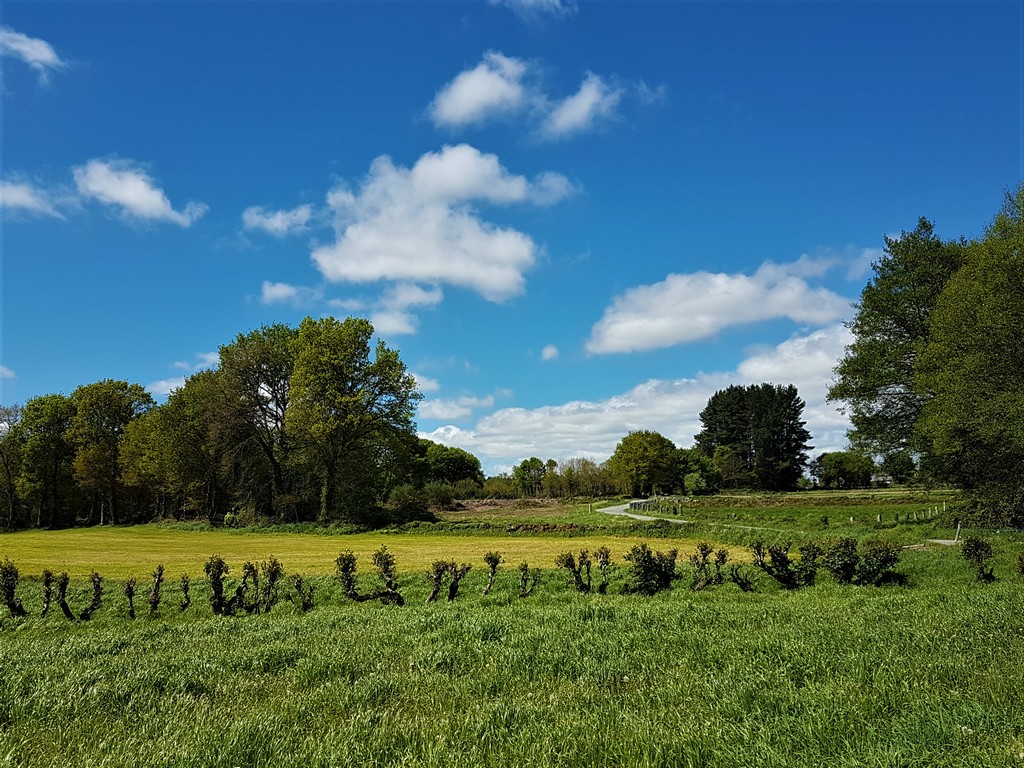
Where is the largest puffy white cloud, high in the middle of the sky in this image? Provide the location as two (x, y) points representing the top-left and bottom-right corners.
(312, 144), (572, 309)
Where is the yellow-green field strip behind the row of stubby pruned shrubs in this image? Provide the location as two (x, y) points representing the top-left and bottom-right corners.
(0, 525), (720, 579)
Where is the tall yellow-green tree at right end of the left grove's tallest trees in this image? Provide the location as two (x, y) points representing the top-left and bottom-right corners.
(288, 317), (421, 521)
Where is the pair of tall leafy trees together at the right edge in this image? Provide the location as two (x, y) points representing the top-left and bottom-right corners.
(828, 184), (1024, 527)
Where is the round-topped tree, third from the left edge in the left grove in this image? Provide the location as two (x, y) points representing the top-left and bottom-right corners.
(70, 379), (155, 524)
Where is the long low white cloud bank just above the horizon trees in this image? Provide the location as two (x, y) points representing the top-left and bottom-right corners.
(421, 325), (850, 473)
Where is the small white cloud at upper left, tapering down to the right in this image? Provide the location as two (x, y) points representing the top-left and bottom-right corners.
(74, 160), (208, 226)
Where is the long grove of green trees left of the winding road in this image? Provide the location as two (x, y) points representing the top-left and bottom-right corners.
(0, 317), (483, 529)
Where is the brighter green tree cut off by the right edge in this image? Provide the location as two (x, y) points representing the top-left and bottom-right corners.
(918, 184), (1024, 525)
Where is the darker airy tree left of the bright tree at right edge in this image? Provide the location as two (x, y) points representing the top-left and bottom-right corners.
(828, 218), (967, 456)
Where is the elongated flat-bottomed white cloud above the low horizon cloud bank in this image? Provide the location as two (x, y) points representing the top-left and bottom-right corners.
(587, 257), (850, 354)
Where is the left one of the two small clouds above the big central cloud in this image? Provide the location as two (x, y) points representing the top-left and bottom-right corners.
(430, 51), (526, 127)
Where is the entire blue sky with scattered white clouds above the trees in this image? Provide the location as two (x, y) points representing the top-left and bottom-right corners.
(0, 0), (1024, 472)
